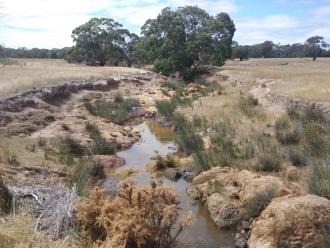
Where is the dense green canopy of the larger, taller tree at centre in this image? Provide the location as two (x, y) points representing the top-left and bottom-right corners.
(135, 6), (235, 76)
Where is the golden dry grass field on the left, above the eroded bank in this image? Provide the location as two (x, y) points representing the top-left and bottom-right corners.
(0, 59), (147, 98)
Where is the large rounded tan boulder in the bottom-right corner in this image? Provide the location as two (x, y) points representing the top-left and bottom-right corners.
(248, 194), (330, 248)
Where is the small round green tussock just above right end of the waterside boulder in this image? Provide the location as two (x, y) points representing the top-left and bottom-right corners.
(256, 151), (282, 172)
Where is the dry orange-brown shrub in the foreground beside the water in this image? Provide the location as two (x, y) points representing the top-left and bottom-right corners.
(77, 180), (192, 248)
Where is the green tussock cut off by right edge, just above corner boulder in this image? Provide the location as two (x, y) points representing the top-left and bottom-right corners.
(307, 160), (330, 199)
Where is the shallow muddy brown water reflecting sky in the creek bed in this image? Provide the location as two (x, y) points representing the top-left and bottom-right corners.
(107, 121), (234, 248)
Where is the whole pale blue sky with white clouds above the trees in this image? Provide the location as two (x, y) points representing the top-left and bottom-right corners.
(0, 0), (330, 48)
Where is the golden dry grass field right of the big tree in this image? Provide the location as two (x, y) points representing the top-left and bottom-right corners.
(220, 58), (330, 101)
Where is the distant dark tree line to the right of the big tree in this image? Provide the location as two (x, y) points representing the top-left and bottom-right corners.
(233, 36), (330, 60)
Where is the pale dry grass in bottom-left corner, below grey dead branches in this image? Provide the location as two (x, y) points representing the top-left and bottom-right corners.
(0, 215), (81, 248)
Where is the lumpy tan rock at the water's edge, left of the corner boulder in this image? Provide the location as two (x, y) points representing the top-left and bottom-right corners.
(188, 167), (292, 232)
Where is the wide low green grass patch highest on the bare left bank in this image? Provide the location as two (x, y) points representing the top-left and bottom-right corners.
(85, 95), (139, 125)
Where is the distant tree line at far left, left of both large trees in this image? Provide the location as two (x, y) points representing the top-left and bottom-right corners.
(0, 46), (70, 59)
